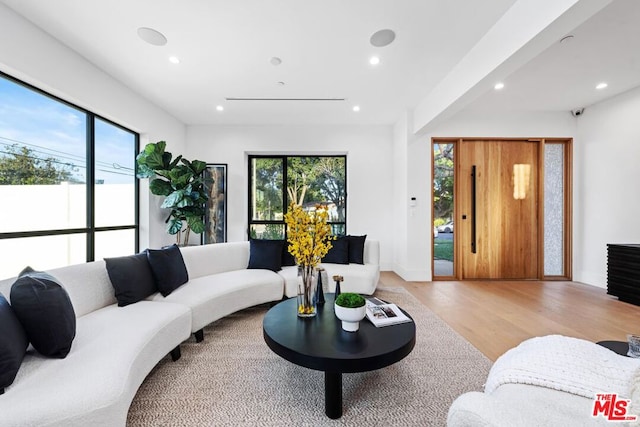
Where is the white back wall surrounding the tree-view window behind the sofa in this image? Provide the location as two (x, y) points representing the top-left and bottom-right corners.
(186, 125), (396, 270)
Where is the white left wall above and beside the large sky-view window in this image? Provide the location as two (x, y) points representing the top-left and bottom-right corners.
(0, 4), (185, 248)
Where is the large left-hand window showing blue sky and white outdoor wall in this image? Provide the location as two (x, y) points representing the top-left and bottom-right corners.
(0, 73), (139, 279)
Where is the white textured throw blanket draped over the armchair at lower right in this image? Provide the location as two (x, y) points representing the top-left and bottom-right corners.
(485, 335), (640, 400)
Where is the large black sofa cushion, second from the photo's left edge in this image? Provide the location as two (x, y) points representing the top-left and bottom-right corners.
(11, 267), (76, 359)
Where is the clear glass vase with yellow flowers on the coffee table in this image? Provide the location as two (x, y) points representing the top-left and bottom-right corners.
(284, 203), (335, 317)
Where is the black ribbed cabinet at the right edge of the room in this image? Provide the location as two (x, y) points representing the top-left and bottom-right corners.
(607, 244), (640, 305)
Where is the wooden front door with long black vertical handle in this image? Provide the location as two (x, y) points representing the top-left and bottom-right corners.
(455, 140), (539, 279)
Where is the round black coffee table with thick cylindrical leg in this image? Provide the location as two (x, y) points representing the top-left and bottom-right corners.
(262, 294), (416, 419)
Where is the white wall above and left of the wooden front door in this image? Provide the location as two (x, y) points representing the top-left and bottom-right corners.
(404, 110), (576, 280)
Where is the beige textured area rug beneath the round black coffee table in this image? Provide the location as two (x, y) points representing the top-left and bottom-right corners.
(127, 288), (491, 426)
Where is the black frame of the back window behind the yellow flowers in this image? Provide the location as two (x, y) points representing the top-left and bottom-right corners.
(247, 154), (348, 240)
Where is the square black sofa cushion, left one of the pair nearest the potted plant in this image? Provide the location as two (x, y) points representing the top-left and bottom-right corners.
(104, 252), (158, 307)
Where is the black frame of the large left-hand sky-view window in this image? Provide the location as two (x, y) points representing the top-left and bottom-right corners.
(0, 71), (140, 262)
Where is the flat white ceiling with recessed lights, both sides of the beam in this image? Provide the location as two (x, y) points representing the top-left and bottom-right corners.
(0, 0), (640, 124)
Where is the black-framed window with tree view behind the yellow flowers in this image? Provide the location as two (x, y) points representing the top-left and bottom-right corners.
(249, 156), (347, 239)
